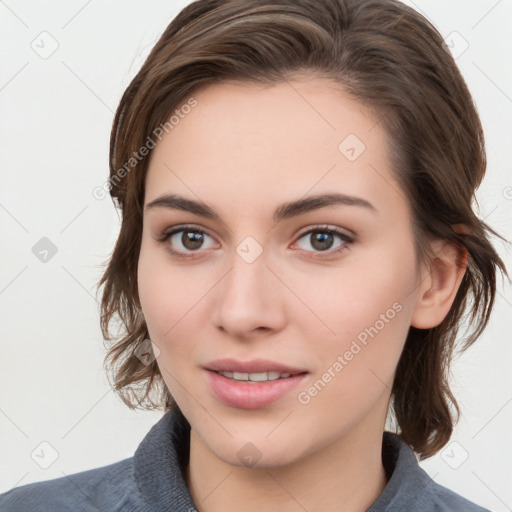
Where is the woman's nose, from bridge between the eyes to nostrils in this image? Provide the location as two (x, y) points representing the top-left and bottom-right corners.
(213, 242), (286, 339)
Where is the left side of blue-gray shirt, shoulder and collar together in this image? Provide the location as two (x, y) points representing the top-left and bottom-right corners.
(0, 412), (195, 512)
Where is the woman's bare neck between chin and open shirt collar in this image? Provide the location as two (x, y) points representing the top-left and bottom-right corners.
(185, 414), (387, 512)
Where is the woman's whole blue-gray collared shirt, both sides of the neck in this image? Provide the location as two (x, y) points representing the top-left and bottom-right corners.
(0, 410), (490, 512)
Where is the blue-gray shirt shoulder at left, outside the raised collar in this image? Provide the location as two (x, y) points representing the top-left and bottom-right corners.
(0, 457), (139, 512)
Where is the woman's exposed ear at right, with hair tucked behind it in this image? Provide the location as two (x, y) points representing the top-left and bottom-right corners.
(411, 234), (469, 329)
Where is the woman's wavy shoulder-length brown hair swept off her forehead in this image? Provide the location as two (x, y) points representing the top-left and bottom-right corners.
(98, 0), (508, 459)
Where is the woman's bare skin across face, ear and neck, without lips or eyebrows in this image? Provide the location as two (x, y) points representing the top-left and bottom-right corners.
(138, 77), (464, 512)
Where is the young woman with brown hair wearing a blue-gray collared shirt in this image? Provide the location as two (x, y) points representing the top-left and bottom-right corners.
(0, 0), (506, 512)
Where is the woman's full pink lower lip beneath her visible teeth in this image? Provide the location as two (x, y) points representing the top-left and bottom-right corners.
(206, 370), (307, 409)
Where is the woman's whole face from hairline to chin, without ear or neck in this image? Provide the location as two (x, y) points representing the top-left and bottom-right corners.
(138, 79), (424, 467)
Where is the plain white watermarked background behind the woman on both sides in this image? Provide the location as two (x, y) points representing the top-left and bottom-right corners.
(0, 0), (512, 511)
